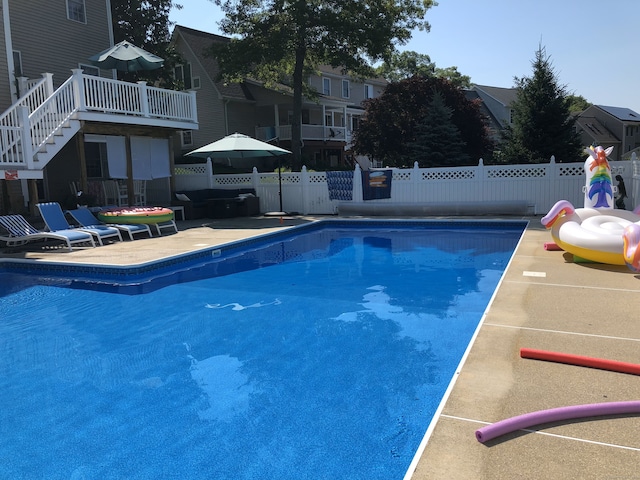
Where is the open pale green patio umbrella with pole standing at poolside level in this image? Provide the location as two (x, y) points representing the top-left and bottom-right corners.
(186, 133), (291, 213)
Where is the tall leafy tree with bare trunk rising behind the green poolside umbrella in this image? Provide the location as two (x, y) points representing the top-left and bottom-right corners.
(212, 0), (436, 169)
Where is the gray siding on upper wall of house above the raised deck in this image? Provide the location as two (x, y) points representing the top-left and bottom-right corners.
(9, 0), (111, 87)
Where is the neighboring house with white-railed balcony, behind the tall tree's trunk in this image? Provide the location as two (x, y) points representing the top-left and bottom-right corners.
(173, 25), (387, 168)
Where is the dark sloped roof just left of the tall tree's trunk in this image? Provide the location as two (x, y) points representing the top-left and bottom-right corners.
(173, 25), (253, 100)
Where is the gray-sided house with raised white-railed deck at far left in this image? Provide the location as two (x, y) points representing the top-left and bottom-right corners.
(0, 0), (198, 212)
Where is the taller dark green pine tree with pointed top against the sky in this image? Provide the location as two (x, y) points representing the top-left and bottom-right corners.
(502, 46), (582, 163)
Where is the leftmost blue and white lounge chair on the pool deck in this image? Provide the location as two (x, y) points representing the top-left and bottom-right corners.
(0, 215), (96, 251)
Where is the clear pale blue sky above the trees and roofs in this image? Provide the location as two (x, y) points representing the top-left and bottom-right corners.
(170, 0), (640, 113)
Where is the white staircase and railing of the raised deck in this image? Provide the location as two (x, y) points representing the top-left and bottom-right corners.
(0, 69), (198, 180)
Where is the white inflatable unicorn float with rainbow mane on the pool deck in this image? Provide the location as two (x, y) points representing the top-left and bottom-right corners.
(542, 146), (640, 272)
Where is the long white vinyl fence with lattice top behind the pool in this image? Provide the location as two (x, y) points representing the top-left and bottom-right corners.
(174, 155), (640, 215)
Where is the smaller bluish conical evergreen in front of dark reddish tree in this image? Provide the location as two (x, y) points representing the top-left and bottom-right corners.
(407, 90), (470, 168)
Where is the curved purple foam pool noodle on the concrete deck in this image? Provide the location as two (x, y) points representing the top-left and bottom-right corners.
(476, 401), (640, 443)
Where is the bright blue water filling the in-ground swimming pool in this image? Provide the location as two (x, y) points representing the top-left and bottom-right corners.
(0, 222), (524, 480)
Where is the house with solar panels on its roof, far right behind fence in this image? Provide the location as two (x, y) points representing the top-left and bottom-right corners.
(576, 105), (640, 160)
